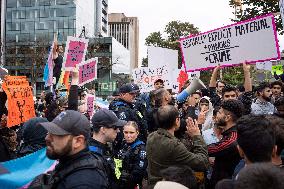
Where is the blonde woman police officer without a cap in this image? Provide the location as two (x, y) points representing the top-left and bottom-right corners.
(118, 121), (147, 189)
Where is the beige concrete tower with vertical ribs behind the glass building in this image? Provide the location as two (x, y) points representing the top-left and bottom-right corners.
(108, 13), (139, 70)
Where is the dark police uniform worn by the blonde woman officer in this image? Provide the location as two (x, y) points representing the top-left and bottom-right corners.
(118, 139), (148, 189)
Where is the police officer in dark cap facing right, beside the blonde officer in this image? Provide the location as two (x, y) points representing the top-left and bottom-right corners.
(89, 109), (126, 189)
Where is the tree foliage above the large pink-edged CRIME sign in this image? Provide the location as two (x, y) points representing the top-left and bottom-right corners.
(229, 0), (284, 34)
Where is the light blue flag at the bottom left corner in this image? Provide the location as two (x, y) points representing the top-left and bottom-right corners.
(0, 148), (57, 189)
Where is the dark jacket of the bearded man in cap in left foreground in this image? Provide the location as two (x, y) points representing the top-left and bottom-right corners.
(29, 149), (108, 189)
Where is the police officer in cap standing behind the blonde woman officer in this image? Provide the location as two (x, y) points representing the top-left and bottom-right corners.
(110, 84), (147, 142)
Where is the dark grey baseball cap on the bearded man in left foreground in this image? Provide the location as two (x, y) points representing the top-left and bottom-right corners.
(40, 110), (91, 139)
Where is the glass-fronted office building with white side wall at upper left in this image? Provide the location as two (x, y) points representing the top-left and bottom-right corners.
(1, 0), (108, 91)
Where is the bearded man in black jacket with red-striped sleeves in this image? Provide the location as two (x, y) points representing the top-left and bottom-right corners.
(208, 100), (244, 188)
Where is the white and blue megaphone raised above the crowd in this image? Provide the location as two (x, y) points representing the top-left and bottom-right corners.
(177, 77), (206, 103)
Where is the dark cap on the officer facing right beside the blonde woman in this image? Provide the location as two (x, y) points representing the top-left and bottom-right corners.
(92, 108), (127, 127)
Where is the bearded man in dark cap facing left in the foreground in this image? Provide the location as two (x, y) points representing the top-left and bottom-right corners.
(29, 110), (108, 189)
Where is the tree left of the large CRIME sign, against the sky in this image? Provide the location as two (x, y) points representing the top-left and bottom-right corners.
(143, 21), (199, 68)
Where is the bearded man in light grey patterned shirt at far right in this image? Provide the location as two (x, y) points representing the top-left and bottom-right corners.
(251, 83), (276, 115)
